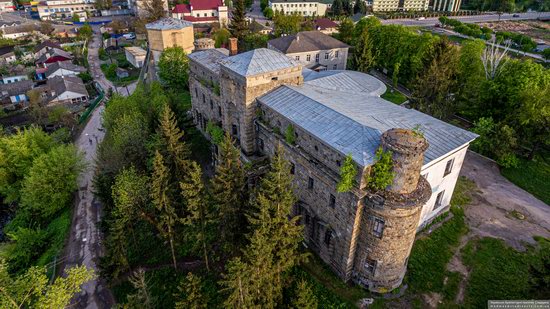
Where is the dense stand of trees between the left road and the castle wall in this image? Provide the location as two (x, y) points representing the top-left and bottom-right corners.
(94, 84), (315, 308)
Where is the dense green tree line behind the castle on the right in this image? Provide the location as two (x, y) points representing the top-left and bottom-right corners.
(338, 18), (550, 167)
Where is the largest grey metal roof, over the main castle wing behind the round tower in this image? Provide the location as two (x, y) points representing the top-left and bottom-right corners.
(258, 71), (477, 166)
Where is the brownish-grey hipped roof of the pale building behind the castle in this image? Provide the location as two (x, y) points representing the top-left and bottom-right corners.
(268, 31), (349, 54)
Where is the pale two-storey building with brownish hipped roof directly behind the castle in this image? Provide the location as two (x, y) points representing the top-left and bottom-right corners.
(267, 31), (349, 71)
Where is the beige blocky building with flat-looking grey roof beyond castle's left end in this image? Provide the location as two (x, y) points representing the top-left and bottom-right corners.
(145, 18), (195, 63)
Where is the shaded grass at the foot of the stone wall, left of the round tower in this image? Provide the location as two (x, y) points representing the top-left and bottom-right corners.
(300, 250), (370, 308)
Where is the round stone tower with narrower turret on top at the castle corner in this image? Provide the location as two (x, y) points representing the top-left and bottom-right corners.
(361, 129), (431, 293)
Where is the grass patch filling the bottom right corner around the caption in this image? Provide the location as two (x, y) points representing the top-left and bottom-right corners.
(462, 238), (550, 308)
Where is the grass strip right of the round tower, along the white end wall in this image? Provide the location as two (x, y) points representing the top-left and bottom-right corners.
(405, 177), (475, 298)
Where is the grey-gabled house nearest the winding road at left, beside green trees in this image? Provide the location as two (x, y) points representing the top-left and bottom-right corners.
(46, 75), (88, 105)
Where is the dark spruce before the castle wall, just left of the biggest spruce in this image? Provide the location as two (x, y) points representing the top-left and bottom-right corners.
(211, 133), (248, 253)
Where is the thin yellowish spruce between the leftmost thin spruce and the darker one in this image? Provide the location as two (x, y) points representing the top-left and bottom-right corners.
(180, 162), (214, 270)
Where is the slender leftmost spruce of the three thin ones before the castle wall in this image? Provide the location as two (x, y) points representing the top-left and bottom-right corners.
(151, 151), (179, 269)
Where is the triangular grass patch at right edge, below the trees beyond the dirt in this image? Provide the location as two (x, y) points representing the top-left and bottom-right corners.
(501, 156), (550, 205)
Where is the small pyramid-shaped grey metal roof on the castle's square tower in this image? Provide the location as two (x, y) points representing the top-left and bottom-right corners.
(220, 48), (300, 76)
